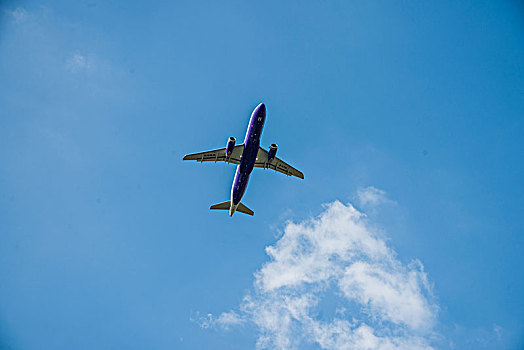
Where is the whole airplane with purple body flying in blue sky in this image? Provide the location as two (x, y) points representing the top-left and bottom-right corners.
(183, 103), (304, 216)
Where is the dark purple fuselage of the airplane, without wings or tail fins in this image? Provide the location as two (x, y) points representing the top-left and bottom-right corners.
(229, 103), (266, 215)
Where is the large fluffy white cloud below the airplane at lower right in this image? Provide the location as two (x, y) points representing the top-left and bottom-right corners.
(201, 201), (438, 349)
